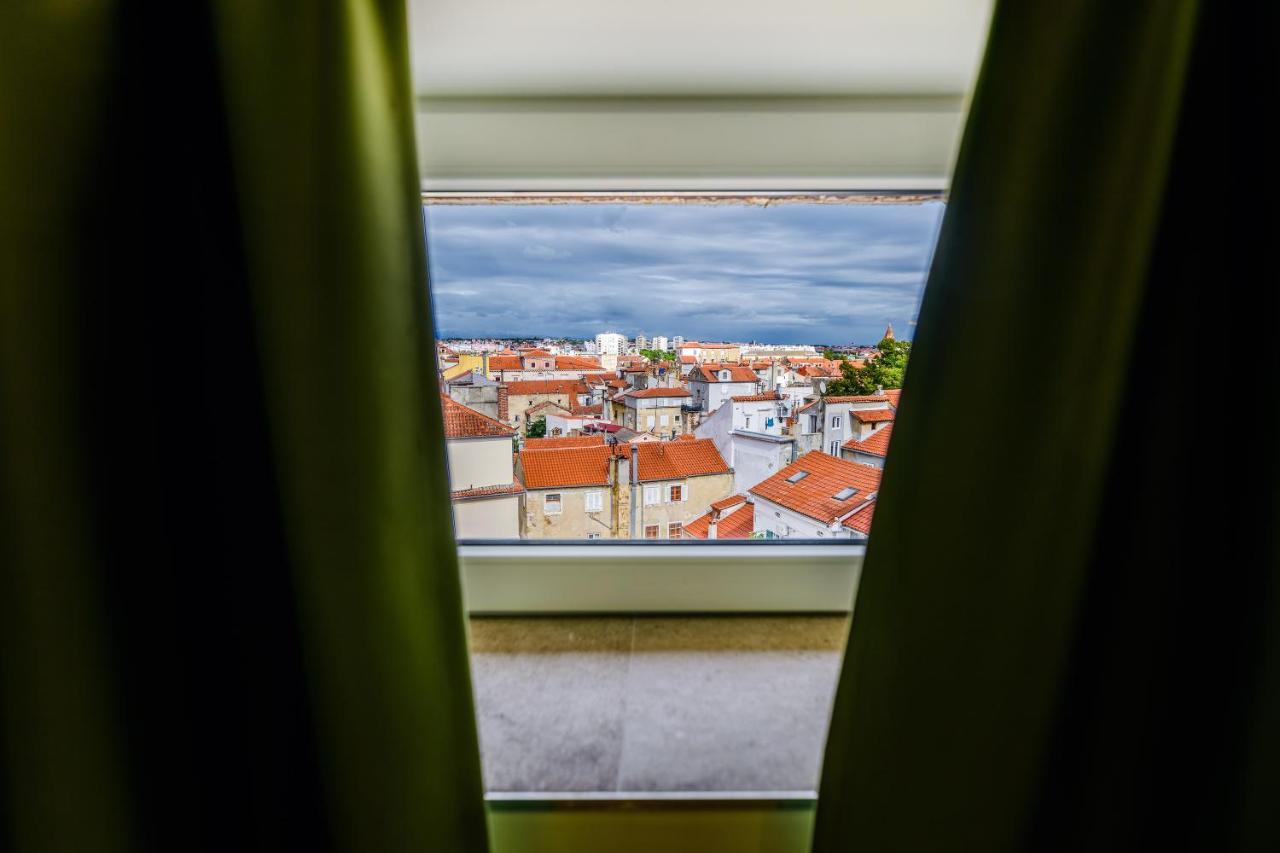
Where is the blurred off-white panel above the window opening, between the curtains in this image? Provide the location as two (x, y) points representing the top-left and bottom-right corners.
(408, 0), (992, 190)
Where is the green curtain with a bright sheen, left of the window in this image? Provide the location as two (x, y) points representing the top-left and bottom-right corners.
(0, 0), (486, 852)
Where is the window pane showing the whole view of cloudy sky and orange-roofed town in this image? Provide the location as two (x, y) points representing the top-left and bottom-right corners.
(426, 197), (942, 540)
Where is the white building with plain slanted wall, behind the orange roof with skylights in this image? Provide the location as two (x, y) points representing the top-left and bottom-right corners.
(695, 394), (796, 493)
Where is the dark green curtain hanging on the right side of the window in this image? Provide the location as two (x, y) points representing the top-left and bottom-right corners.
(814, 0), (1280, 853)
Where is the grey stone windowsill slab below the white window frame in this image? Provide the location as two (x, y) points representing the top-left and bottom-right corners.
(471, 616), (849, 803)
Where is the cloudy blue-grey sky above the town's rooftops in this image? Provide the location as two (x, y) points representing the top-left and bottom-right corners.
(426, 202), (942, 345)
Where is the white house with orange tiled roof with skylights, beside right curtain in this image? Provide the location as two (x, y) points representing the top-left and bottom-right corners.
(750, 451), (881, 540)
